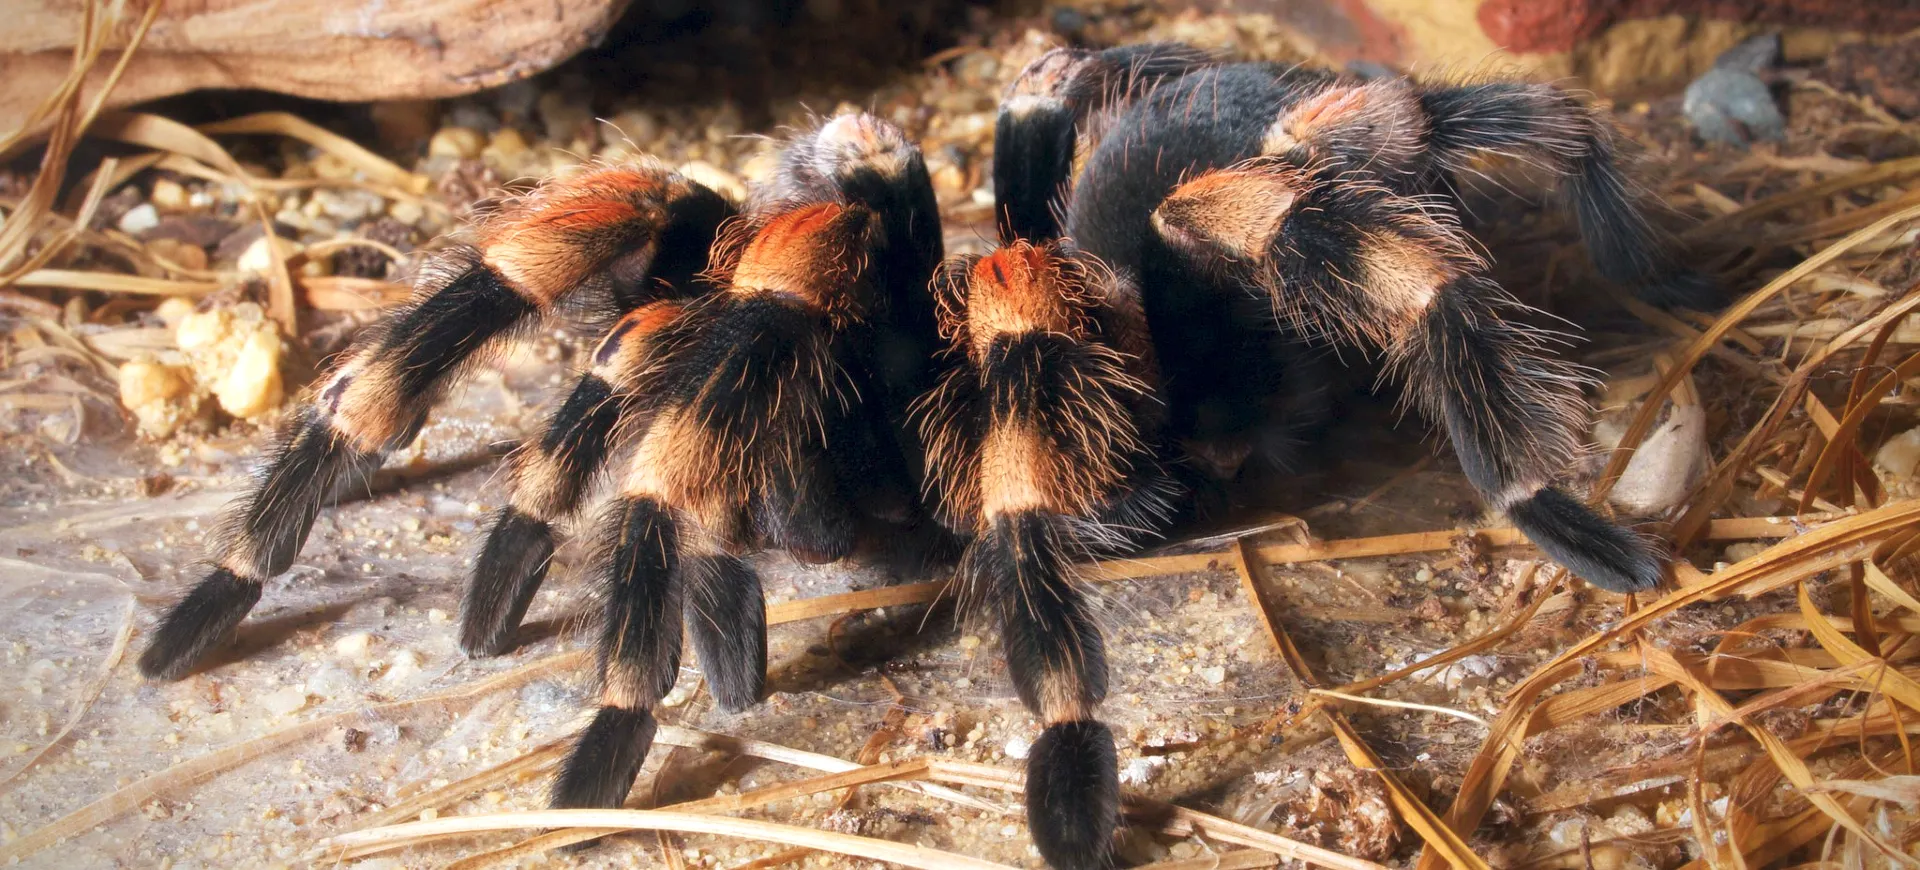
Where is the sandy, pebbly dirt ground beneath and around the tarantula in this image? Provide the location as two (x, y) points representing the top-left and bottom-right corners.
(0, 3), (1920, 868)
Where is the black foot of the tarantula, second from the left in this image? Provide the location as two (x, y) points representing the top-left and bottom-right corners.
(461, 507), (553, 659)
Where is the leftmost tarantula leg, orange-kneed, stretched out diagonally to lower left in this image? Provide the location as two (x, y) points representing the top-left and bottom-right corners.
(140, 169), (726, 680)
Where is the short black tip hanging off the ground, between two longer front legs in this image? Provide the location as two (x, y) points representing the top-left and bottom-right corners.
(682, 553), (766, 713)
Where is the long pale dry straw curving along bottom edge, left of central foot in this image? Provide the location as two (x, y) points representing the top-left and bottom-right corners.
(326, 810), (1006, 870)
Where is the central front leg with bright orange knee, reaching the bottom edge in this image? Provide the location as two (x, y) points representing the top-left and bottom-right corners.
(920, 242), (1171, 870)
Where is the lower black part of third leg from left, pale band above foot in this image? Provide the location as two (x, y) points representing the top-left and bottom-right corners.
(549, 497), (682, 809)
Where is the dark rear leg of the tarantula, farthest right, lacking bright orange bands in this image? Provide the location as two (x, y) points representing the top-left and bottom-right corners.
(1419, 83), (1722, 309)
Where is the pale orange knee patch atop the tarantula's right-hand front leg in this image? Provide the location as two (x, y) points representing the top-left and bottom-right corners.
(1152, 169), (1302, 263)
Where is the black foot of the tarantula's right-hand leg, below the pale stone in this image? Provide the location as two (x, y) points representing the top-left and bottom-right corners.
(1507, 488), (1665, 592)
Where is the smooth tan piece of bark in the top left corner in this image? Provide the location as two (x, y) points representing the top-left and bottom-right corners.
(0, 0), (630, 136)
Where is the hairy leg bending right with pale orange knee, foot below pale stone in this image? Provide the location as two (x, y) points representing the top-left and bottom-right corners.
(1154, 159), (1663, 592)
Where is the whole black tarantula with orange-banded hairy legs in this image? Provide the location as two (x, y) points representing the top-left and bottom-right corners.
(140, 44), (1713, 868)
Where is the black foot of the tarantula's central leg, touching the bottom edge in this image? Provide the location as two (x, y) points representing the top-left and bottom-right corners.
(1027, 720), (1119, 870)
